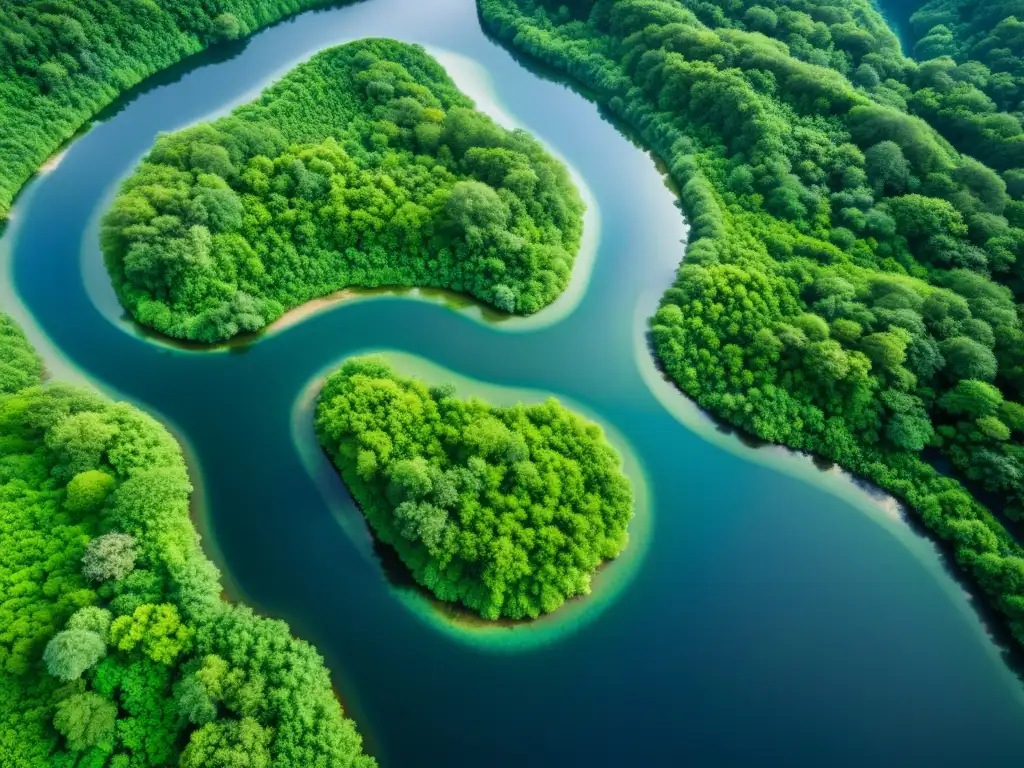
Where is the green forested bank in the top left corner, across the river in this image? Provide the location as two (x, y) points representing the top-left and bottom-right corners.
(0, 0), (364, 218)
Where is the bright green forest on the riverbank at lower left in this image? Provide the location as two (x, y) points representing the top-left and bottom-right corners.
(0, 317), (375, 768)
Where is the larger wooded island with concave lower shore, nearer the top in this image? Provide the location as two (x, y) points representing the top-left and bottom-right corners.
(102, 40), (583, 342)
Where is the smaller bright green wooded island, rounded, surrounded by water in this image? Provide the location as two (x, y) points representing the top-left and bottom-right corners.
(315, 357), (633, 620)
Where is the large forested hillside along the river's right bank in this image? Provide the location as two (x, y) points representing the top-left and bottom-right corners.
(479, 0), (1024, 651)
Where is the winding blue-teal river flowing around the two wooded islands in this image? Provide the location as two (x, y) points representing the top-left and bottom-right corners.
(3, 0), (1024, 766)
